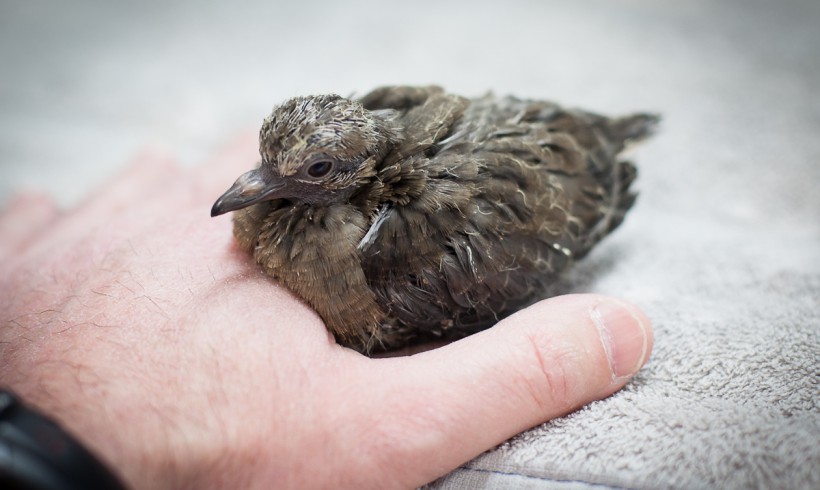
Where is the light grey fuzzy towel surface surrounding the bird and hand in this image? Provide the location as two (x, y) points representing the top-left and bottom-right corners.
(0, 0), (820, 488)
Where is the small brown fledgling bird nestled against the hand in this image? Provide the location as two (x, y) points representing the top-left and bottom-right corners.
(211, 86), (660, 355)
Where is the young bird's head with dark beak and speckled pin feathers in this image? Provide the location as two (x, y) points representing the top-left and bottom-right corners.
(211, 95), (396, 216)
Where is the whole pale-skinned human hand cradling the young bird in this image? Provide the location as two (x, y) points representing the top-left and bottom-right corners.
(0, 131), (652, 489)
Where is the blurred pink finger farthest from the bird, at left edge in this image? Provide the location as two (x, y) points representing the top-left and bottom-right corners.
(0, 192), (58, 257)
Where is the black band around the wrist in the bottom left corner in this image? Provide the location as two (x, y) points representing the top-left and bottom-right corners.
(0, 389), (124, 490)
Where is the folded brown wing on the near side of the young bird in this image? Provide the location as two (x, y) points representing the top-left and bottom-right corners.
(363, 95), (652, 332)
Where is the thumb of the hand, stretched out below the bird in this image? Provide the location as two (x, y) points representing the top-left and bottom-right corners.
(362, 295), (652, 486)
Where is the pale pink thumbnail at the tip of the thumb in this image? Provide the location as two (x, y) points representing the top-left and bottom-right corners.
(590, 300), (649, 378)
